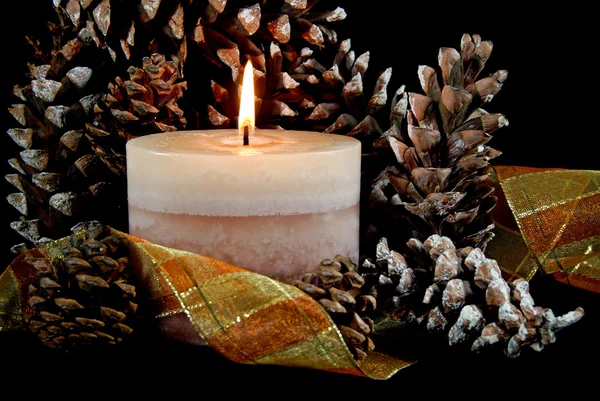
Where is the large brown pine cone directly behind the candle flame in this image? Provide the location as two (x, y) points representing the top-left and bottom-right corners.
(193, 1), (368, 131)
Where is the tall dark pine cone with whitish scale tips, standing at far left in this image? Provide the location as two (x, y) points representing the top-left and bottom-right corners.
(6, 49), (118, 248)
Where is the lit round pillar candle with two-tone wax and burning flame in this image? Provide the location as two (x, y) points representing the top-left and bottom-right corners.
(126, 61), (361, 282)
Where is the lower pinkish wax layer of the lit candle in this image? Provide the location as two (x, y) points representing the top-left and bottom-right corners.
(129, 204), (359, 283)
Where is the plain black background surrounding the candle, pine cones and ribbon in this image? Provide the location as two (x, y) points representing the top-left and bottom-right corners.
(0, 0), (600, 399)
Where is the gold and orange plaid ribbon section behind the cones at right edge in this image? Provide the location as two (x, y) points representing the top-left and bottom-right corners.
(486, 166), (600, 292)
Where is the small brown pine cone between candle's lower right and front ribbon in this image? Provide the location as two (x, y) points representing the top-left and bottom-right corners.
(293, 255), (377, 360)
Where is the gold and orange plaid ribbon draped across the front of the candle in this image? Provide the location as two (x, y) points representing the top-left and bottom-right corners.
(0, 230), (413, 380)
